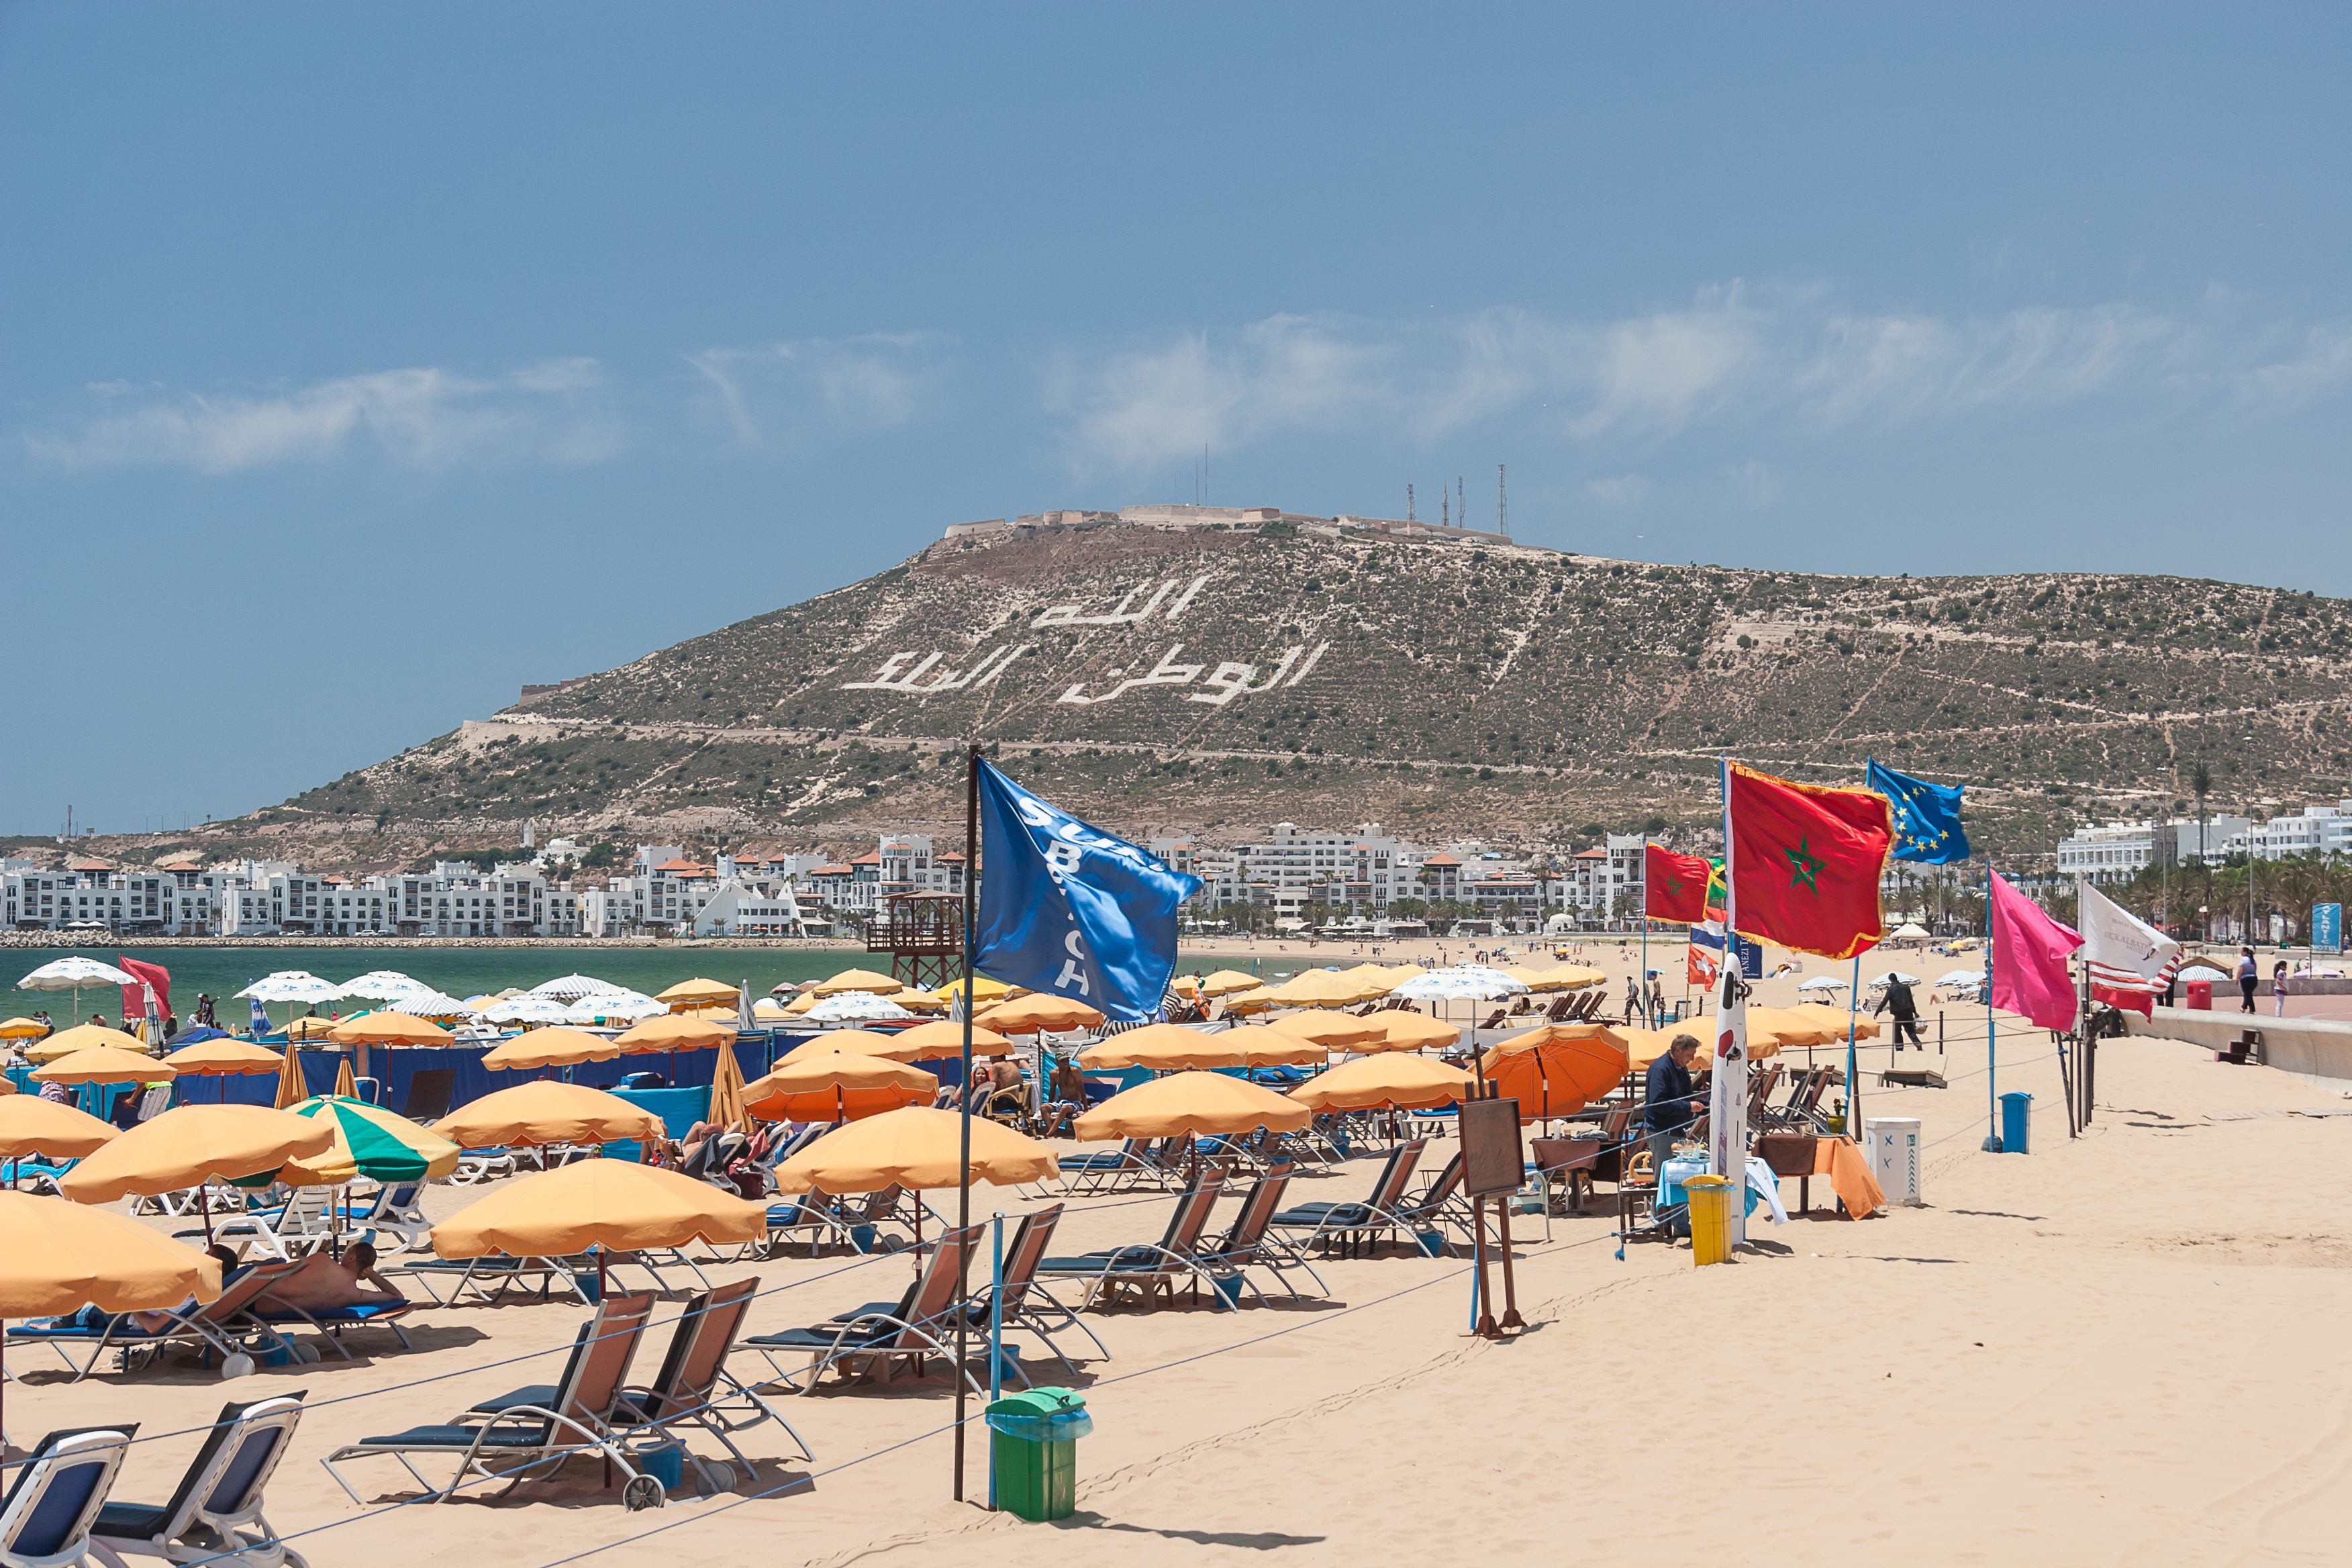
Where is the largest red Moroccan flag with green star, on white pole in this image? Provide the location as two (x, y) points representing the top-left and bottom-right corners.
(1724, 762), (1894, 959)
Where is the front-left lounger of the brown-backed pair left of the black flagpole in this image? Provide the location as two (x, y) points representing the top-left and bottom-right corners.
(320, 1295), (661, 1509)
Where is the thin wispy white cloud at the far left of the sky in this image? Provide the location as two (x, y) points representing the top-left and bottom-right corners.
(28, 360), (621, 475)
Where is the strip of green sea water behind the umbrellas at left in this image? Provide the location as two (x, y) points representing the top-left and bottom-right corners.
(0, 947), (865, 1027)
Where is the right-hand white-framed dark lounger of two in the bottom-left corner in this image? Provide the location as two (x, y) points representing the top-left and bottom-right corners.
(89, 1391), (308, 1568)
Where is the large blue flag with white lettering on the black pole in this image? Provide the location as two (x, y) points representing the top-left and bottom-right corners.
(971, 762), (1202, 1022)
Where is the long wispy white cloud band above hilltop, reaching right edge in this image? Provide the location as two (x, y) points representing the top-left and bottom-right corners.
(1046, 285), (2352, 472)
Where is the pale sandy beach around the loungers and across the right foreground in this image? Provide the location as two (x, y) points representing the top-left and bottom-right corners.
(7, 975), (2352, 1568)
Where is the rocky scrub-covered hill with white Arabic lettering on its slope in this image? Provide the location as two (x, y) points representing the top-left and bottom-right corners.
(114, 524), (2352, 863)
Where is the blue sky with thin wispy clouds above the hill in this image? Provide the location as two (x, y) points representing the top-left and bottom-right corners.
(0, 5), (2352, 832)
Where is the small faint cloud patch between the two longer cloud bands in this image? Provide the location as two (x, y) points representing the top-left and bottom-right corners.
(687, 334), (948, 449)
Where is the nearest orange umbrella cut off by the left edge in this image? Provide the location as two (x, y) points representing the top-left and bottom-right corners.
(0, 1192), (221, 1319)
